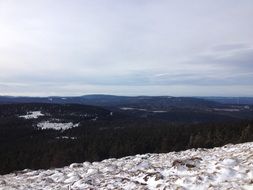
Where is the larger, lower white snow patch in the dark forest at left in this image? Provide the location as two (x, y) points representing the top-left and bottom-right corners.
(37, 121), (79, 131)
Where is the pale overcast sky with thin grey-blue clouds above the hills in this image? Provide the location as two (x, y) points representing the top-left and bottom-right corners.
(0, 0), (253, 96)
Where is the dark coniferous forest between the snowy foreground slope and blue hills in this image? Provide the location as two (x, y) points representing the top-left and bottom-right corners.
(0, 103), (253, 174)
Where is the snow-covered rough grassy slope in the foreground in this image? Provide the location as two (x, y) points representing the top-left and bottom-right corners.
(0, 143), (253, 190)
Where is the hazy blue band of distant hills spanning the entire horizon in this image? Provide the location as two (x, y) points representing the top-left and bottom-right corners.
(0, 94), (253, 109)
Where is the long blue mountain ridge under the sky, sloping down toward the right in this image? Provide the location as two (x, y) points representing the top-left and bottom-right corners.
(0, 94), (223, 106)
